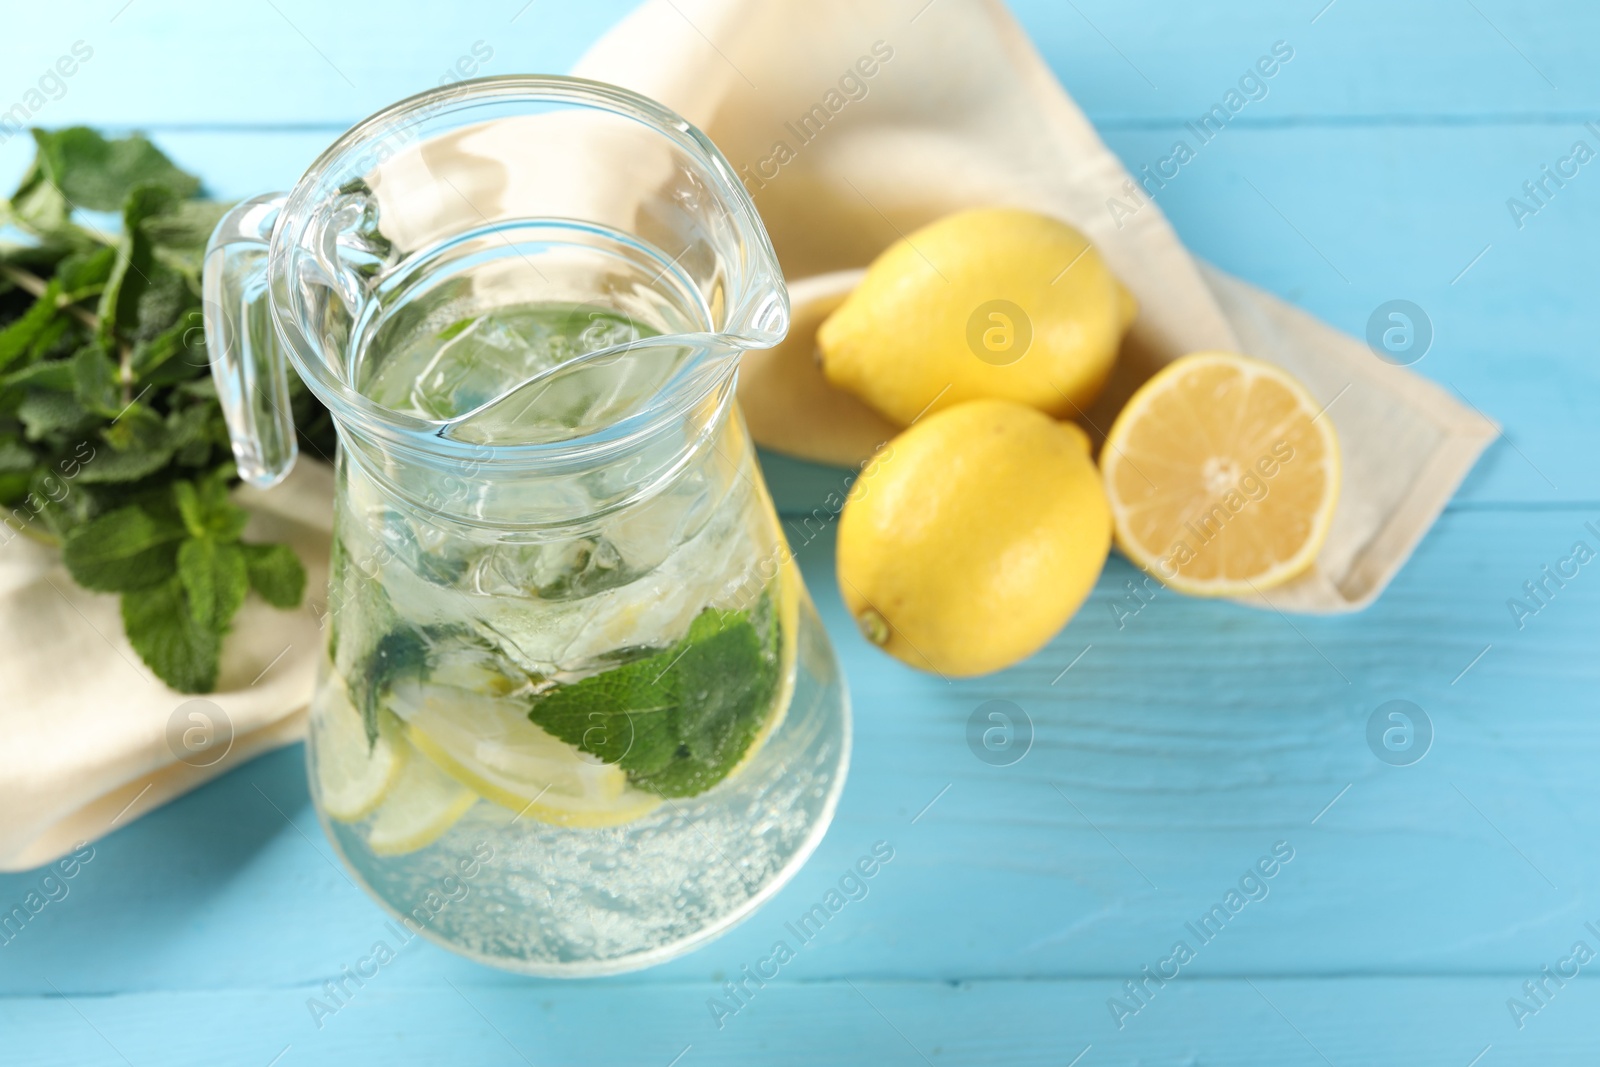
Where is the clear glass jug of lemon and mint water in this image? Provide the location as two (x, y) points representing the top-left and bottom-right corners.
(205, 77), (850, 976)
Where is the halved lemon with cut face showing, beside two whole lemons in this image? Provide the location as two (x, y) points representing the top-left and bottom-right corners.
(1101, 352), (1339, 597)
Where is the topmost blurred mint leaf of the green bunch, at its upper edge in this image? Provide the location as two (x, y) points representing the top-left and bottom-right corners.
(19, 126), (200, 211)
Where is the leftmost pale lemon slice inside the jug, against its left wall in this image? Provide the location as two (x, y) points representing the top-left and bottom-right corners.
(310, 677), (406, 822)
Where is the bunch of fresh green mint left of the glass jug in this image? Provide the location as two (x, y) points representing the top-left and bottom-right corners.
(0, 126), (333, 693)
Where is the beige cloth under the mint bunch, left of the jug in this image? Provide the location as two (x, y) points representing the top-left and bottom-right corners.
(0, 459), (333, 870)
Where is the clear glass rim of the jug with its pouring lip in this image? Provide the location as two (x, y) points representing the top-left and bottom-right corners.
(267, 74), (789, 467)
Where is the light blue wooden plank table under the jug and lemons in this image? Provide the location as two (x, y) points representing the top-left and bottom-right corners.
(0, 0), (1600, 1067)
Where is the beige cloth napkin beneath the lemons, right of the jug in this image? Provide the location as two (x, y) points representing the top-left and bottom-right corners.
(574, 0), (1498, 613)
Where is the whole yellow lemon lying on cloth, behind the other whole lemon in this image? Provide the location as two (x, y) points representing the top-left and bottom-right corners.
(816, 208), (1138, 426)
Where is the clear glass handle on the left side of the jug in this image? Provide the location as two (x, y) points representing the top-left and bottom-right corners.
(202, 194), (299, 490)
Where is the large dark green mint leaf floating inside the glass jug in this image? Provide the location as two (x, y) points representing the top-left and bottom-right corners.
(528, 593), (778, 797)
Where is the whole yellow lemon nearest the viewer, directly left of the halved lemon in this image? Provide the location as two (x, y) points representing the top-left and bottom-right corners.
(838, 400), (1110, 675)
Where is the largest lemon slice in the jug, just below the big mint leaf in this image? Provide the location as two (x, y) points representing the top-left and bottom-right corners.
(390, 683), (661, 827)
